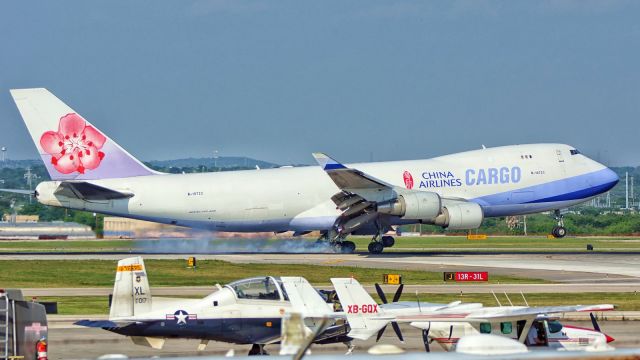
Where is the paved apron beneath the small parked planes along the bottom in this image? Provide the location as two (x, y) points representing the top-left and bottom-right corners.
(49, 321), (640, 359)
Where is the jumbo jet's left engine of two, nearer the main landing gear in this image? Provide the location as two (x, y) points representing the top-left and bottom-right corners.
(378, 191), (442, 221)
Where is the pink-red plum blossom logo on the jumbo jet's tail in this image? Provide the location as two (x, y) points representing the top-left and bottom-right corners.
(40, 113), (107, 174)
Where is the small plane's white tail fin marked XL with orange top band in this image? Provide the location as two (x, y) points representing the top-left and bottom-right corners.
(109, 256), (151, 320)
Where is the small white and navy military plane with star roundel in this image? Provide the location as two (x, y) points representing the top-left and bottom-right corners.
(75, 256), (351, 355)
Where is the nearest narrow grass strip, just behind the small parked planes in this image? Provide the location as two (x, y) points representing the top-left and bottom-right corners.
(38, 293), (640, 315)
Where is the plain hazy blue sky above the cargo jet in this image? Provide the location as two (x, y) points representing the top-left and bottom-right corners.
(0, 0), (640, 166)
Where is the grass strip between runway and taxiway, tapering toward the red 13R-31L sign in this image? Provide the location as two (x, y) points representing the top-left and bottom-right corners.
(0, 260), (548, 288)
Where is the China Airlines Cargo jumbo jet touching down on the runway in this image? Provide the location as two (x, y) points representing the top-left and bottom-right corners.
(2, 89), (619, 253)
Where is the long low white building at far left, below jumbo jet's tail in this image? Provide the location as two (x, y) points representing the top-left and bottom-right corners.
(0, 221), (96, 240)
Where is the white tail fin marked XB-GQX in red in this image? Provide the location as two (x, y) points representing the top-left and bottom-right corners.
(331, 278), (392, 340)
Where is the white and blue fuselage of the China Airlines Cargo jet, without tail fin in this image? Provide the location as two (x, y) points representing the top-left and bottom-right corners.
(37, 144), (618, 232)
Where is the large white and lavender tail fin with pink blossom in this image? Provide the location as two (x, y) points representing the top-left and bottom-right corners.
(11, 88), (157, 180)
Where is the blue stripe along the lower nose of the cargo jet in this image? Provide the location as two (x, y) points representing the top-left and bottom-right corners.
(471, 168), (620, 207)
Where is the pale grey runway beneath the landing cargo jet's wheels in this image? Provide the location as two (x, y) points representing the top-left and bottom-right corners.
(7, 252), (640, 285)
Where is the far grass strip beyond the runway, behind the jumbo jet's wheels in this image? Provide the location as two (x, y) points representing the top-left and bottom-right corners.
(0, 236), (640, 253)
